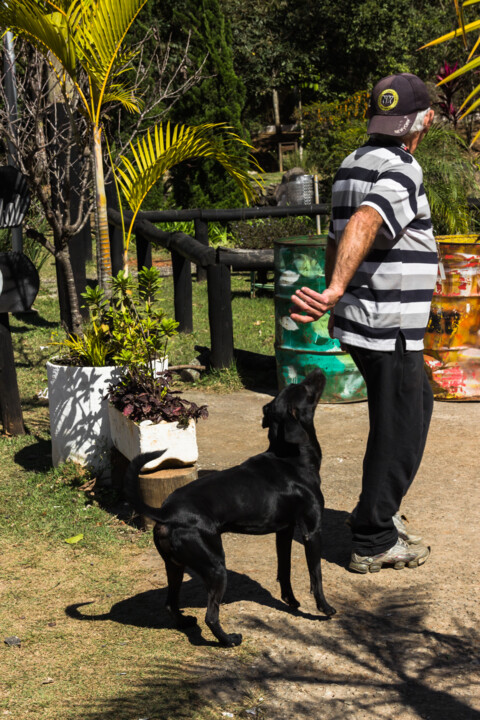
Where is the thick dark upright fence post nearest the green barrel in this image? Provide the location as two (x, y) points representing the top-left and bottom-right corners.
(207, 263), (233, 369)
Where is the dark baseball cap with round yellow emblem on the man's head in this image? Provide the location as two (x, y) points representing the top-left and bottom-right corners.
(367, 73), (430, 137)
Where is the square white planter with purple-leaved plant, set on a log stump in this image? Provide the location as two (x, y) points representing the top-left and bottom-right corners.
(108, 404), (198, 470)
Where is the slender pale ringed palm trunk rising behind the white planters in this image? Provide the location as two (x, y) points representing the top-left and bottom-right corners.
(93, 125), (112, 295)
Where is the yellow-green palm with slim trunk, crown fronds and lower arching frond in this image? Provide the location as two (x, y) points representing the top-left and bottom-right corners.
(0, 0), (260, 287)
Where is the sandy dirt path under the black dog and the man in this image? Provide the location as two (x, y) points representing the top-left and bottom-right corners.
(138, 391), (480, 720)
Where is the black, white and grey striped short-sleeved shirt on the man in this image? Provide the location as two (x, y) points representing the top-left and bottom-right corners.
(329, 139), (437, 351)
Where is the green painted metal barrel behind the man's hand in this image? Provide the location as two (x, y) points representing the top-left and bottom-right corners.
(275, 235), (367, 403)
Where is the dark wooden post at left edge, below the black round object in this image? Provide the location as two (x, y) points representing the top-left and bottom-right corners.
(0, 313), (25, 435)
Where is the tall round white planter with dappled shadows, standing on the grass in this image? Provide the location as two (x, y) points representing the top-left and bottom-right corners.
(47, 360), (168, 474)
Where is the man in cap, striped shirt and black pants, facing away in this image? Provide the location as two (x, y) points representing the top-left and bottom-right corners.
(292, 73), (437, 573)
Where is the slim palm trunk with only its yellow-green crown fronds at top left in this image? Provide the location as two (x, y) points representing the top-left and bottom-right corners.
(0, 0), (146, 285)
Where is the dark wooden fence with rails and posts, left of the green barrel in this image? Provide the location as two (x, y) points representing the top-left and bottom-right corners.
(108, 204), (330, 368)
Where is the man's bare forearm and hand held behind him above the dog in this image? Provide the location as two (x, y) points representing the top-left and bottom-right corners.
(291, 205), (383, 323)
